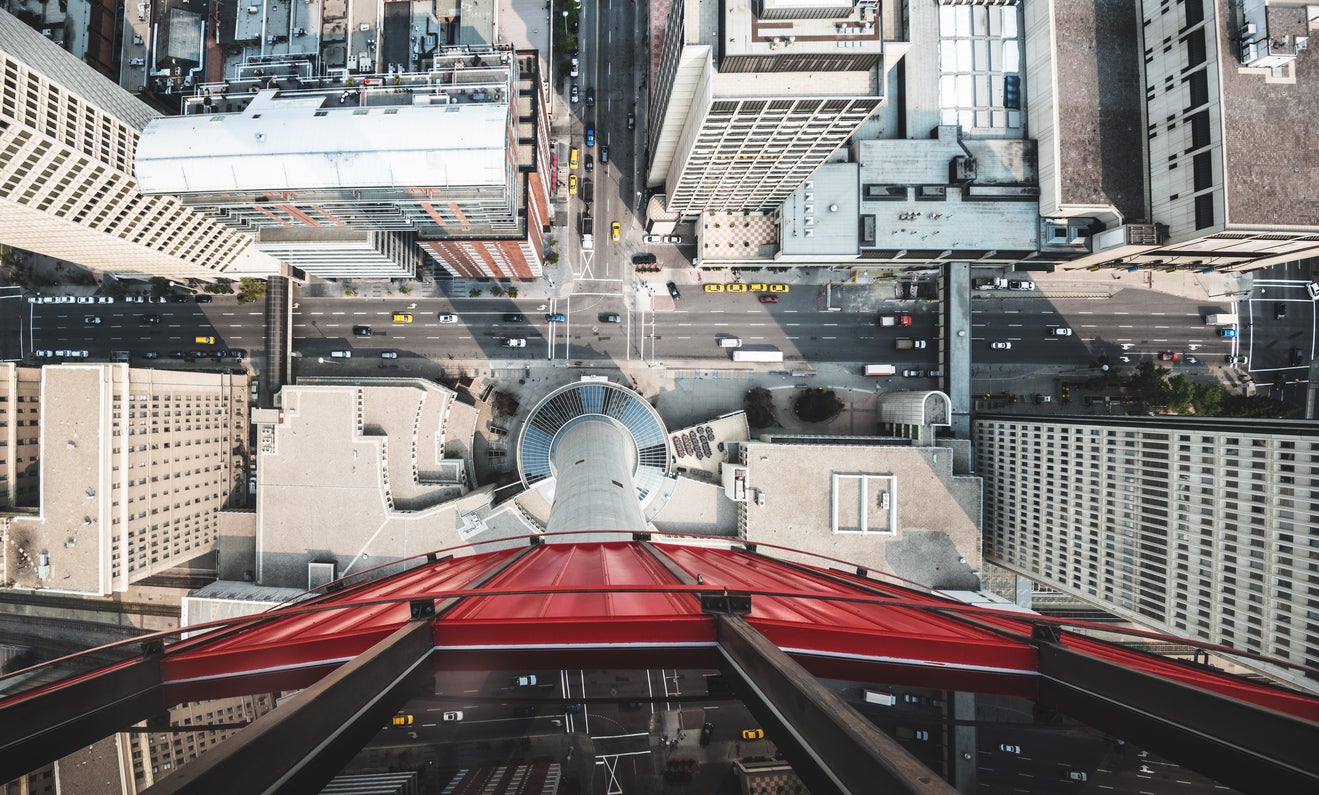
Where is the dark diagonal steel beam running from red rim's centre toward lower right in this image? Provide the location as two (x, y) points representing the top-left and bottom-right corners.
(714, 614), (956, 795)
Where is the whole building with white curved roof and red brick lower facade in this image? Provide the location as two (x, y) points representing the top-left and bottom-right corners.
(136, 47), (550, 278)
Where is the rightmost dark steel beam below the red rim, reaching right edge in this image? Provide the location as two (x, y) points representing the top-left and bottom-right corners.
(1035, 638), (1319, 792)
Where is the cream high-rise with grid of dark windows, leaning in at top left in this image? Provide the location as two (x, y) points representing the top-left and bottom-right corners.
(0, 11), (278, 278)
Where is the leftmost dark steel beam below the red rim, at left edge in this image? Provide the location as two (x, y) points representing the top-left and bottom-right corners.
(0, 646), (165, 782)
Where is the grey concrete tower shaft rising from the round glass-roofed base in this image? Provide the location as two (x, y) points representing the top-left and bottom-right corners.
(546, 417), (646, 542)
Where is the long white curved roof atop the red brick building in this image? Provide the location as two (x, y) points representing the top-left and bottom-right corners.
(135, 91), (508, 195)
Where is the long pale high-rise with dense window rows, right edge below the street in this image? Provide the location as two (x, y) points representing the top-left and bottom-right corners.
(973, 415), (1319, 688)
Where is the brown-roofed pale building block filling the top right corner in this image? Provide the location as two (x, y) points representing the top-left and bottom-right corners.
(1022, 0), (1319, 268)
